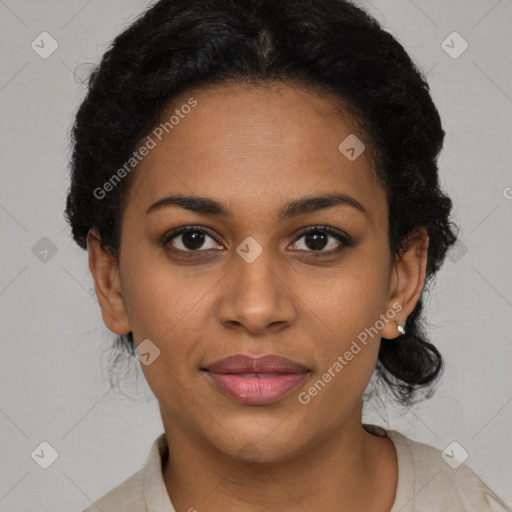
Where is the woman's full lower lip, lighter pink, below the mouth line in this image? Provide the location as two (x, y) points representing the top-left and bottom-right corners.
(206, 372), (308, 404)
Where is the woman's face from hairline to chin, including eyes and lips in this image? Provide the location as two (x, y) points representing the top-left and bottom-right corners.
(91, 85), (420, 461)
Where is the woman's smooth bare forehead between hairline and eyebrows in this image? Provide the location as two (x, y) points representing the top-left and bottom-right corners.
(127, 84), (386, 222)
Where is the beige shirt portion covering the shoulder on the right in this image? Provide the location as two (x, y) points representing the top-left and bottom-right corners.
(364, 426), (512, 512)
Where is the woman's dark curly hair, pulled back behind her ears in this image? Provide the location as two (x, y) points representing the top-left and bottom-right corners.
(65, 0), (456, 405)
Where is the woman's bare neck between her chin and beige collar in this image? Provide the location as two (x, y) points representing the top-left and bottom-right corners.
(162, 403), (397, 512)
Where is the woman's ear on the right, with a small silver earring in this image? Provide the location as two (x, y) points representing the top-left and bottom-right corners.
(381, 226), (429, 339)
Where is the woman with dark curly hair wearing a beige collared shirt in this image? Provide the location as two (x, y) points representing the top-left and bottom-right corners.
(66, 0), (510, 512)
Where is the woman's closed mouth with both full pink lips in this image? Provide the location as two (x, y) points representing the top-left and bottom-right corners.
(201, 354), (310, 405)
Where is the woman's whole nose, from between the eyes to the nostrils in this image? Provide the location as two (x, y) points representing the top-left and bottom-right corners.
(219, 237), (295, 332)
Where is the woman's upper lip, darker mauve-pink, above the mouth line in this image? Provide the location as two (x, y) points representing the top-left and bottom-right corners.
(205, 354), (309, 373)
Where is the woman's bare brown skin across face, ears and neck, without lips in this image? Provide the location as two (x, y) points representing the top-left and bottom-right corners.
(88, 84), (428, 512)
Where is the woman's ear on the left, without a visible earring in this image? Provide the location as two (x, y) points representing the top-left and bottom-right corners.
(87, 228), (131, 334)
